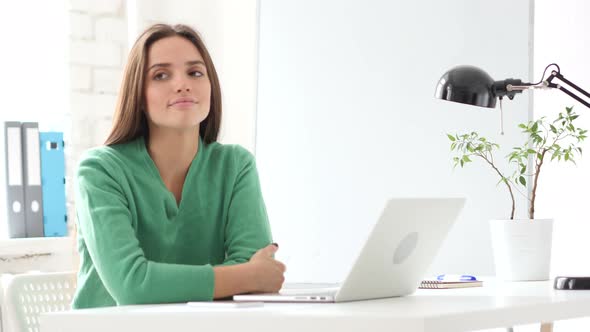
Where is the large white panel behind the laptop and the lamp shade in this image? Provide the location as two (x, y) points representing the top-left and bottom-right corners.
(256, 0), (532, 281)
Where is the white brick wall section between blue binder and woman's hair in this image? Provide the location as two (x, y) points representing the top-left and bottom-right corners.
(66, 0), (127, 241)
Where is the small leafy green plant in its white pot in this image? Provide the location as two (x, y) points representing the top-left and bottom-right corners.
(447, 107), (587, 280)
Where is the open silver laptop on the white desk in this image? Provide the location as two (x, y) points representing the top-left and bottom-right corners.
(233, 198), (465, 302)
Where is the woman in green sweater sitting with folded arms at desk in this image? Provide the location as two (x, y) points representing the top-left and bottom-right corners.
(73, 24), (285, 308)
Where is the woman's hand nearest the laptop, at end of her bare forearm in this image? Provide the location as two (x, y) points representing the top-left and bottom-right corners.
(247, 244), (286, 293)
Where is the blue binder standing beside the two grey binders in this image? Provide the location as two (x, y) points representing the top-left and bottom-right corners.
(39, 132), (68, 237)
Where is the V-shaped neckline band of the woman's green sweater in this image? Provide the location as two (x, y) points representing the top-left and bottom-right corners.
(137, 136), (205, 219)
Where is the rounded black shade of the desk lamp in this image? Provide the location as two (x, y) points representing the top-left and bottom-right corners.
(435, 66), (496, 108)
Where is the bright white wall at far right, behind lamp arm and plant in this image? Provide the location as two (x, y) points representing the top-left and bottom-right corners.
(534, 0), (590, 332)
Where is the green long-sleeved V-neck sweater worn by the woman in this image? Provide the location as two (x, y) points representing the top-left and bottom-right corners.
(72, 138), (271, 308)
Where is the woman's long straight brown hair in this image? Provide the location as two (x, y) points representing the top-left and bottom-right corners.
(104, 24), (221, 145)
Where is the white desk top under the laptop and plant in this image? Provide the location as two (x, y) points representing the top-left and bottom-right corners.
(41, 281), (590, 332)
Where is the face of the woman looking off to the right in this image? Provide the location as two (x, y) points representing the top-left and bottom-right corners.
(145, 36), (211, 129)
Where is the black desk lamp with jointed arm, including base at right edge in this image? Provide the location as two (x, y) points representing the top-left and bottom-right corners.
(434, 63), (590, 289)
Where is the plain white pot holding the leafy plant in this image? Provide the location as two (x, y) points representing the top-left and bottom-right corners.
(490, 219), (553, 281)
